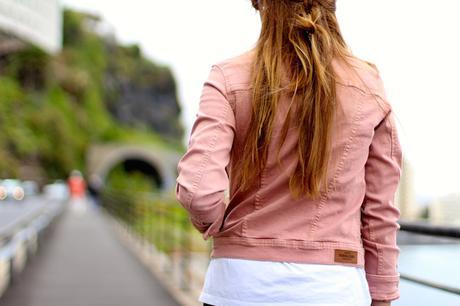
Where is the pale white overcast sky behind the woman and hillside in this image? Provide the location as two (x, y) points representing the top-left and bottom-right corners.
(62, 0), (460, 198)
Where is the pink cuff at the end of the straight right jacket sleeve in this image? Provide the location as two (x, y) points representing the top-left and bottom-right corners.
(366, 273), (400, 301)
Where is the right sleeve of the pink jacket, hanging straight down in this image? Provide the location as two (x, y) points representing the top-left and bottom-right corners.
(361, 108), (402, 301)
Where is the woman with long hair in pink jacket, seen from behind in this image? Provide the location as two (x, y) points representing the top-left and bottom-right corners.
(176, 0), (402, 306)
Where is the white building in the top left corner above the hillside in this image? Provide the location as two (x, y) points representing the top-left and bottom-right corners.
(0, 0), (62, 53)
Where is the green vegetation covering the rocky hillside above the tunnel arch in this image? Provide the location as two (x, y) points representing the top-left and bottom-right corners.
(0, 10), (184, 182)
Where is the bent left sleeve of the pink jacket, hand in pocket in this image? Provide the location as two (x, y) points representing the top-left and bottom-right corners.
(176, 66), (235, 240)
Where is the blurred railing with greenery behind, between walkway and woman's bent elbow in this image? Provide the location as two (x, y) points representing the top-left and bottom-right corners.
(100, 189), (211, 294)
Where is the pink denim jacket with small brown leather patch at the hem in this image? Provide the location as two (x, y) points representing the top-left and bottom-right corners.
(176, 52), (402, 301)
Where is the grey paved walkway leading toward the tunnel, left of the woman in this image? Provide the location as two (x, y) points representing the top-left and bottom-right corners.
(0, 201), (177, 306)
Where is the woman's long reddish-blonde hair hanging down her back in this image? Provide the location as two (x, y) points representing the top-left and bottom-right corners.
(239, 0), (351, 198)
